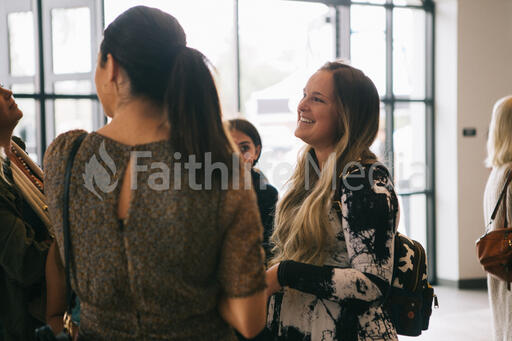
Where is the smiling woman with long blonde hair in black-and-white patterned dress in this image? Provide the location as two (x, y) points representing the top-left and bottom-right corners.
(267, 62), (399, 341)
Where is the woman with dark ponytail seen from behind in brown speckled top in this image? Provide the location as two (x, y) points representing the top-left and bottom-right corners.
(45, 6), (266, 340)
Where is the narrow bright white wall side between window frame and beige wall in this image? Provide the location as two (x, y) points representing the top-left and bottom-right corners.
(435, 0), (459, 280)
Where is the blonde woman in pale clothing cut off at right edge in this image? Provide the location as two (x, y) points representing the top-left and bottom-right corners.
(484, 96), (512, 341)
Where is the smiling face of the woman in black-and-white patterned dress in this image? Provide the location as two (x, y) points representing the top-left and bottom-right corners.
(295, 70), (339, 149)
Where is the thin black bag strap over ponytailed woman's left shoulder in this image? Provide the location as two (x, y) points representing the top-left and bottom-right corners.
(62, 134), (87, 315)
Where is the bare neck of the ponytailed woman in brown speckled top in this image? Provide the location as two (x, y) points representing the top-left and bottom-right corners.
(98, 100), (169, 145)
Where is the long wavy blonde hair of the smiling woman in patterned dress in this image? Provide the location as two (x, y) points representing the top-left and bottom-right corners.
(270, 62), (380, 265)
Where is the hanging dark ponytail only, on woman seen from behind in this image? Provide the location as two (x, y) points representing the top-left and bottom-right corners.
(165, 47), (235, 168)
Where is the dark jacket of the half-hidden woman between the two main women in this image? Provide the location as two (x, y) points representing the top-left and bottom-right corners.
(251, 168), (277, 262)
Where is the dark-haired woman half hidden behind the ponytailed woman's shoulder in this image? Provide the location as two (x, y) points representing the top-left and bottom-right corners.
(228, 119), (277, 260)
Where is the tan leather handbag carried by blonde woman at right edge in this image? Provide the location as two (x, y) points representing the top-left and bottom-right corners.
(476, 171), (512, 290)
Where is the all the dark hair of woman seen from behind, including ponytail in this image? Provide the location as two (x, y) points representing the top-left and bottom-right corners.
(100, 6), (235, 181)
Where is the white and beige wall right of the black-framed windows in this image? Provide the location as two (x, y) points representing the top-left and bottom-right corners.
(436, 0), (512, 280)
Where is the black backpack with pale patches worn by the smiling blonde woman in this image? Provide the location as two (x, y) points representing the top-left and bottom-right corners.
(335, 168), (439, 336)
